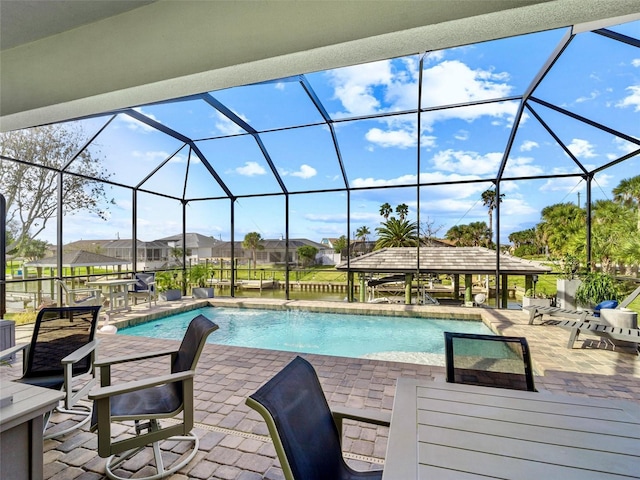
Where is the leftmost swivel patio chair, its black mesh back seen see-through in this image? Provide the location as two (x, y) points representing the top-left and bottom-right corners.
(0, 306), (100, 439)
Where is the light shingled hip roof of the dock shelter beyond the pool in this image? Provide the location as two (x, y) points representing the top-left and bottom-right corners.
(337, 247), (551, 275)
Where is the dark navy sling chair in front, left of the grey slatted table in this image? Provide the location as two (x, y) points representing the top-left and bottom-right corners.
(246, 357), (391, 480)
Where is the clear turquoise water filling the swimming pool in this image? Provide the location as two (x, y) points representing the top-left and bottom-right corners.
(118, 307), (492, 365)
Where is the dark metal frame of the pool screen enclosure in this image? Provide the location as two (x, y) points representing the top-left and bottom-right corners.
(0, 19), (640, 308)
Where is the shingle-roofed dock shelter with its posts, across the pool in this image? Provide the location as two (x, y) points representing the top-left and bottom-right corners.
(337, 247), (551, 305)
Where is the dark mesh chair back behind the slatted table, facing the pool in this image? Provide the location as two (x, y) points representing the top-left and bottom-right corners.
(444, 332), (536, 392)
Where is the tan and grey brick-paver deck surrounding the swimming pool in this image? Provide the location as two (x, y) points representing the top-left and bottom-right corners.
(6, 298), (640, 480)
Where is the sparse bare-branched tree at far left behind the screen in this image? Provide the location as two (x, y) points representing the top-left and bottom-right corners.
(0, 125), (114, 250)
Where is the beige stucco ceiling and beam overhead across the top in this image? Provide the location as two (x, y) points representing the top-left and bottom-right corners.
(0, 0), (640, 131)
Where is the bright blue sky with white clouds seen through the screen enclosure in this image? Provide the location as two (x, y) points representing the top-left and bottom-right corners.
(51, 18), (640, 243)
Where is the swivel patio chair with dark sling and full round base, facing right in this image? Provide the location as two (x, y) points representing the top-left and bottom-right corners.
(89, 315), (218, 480)
